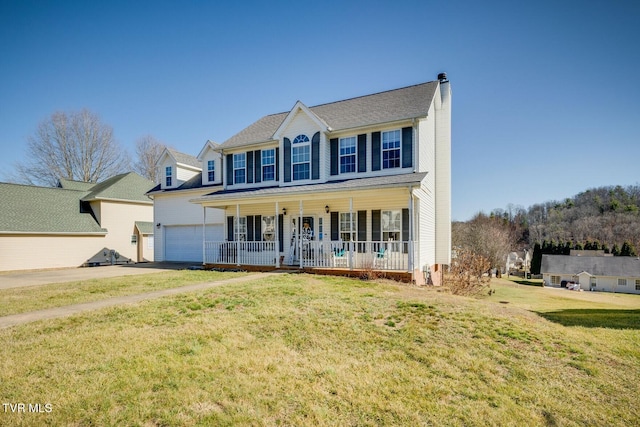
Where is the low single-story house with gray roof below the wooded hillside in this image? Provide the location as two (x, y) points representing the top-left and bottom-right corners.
(540, 255), (640, 294)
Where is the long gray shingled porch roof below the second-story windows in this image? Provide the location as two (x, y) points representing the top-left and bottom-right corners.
(192, 172), (427, 201)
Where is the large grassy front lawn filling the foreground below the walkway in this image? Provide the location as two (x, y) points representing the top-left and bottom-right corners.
(0, 274), (640, 426)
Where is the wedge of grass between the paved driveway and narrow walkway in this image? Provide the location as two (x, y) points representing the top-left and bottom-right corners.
(0, 270), (244, 316)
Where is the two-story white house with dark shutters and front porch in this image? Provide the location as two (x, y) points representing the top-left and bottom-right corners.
(175, 73), (451, 284)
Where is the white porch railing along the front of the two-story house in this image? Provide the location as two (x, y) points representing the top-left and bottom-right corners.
(205, 240), (418, 271)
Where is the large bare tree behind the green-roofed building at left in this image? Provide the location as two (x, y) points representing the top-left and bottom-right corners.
(10, 109), (129, 186)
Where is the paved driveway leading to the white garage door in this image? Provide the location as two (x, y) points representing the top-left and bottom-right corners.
(0, 262), (194, 289)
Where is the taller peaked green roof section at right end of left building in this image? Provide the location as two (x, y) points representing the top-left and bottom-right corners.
(82, 172), (155, 203)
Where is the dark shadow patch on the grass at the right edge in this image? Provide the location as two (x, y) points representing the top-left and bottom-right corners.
(537, 309), (640, 329)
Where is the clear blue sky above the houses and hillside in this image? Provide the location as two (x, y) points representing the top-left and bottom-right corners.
(0, 0), (640, 220)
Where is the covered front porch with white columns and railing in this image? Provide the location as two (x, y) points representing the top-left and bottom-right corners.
(194, 177), (422, 280)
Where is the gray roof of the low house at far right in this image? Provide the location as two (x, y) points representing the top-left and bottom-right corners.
(540, 255), (640, 277)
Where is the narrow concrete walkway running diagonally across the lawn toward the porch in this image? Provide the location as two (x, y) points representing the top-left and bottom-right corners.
(0, 273), (278, 329)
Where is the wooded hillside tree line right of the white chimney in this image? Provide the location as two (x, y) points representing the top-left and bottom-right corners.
(452, 185), (640, 274)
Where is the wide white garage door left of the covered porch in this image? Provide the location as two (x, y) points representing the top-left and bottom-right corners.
(164, 224), (224, 263)
